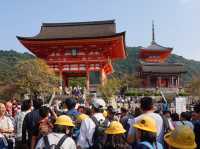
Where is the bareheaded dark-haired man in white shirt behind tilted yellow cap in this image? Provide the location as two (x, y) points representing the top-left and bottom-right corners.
(127, 97), (163, 143)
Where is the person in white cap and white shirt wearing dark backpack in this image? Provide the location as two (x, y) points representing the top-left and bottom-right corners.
(77, 98), (106, 149)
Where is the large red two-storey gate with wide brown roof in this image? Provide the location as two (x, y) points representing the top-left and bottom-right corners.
(17, 20), (126, 88)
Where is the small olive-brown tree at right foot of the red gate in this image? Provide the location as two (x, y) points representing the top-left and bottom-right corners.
(98, 77), (121, 101)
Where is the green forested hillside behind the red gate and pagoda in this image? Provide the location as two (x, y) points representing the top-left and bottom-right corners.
(0, 47), (200, 81)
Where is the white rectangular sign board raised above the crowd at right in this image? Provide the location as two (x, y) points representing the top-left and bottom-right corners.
(175, 97), (187, 114)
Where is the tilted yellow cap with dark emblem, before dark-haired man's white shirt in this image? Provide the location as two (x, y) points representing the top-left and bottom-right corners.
(133, 115), (157, 133)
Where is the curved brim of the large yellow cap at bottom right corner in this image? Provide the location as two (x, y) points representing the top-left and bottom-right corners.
(164, 132), (197, 149)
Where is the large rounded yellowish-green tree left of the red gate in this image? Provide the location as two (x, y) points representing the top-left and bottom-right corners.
(14, 59), (59, 97)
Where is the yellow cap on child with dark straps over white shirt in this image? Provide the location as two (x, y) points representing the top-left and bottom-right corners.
(54, 115), (75, 126)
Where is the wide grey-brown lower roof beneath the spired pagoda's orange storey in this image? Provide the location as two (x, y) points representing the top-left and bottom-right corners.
(140, 63), (186, 73)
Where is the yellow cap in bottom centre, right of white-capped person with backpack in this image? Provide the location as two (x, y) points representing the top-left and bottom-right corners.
(105, 121), (126, 134)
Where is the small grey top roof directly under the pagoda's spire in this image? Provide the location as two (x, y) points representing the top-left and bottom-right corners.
(141, 41), (173, 51)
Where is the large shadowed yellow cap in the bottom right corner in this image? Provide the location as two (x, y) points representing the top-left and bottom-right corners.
(164, 126), (197, 149)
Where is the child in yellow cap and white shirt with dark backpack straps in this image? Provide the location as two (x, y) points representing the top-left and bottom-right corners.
(35, 115), (76, 149)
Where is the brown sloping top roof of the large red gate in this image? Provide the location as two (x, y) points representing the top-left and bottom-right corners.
(17, 20), (116, 40)
